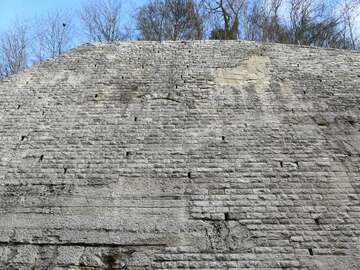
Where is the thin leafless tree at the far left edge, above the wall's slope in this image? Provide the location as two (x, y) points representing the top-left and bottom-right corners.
(0, 22), (28, 78)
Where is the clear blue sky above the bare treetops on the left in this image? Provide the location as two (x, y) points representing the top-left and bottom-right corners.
(0, 0), (144, 31)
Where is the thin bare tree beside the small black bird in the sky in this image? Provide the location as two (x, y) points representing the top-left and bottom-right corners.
(33, 11), (73, 61)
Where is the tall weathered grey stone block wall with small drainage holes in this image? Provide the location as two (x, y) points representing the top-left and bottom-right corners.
(0, 41), (360, 270)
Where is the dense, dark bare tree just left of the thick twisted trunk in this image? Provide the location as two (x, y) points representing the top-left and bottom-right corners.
(136, 0), (204, 41)
